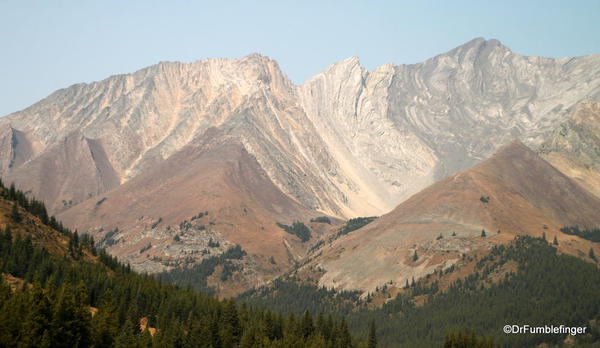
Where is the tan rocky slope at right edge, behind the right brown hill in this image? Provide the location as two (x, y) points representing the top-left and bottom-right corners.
(538, 102), (600, 197)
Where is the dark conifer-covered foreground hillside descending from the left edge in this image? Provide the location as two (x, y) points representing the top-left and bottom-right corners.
(0, 184), (366, 348)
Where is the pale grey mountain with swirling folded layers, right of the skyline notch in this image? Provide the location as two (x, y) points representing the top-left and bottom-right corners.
(298, 39), (600, 215)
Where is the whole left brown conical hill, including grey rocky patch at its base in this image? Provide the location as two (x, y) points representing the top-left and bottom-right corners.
(59, 128), (324, 285)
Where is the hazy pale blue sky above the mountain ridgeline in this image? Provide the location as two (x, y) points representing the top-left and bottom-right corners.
(0, 0), (600, 115)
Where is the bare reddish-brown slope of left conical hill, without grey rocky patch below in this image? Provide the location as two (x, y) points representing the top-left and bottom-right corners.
(59, 128), (322, 286)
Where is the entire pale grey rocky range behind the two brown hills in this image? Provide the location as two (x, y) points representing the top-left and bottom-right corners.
(0, 39), (600, 217)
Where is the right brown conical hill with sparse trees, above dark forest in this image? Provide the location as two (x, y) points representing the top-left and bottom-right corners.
(301, 140), (600, 292)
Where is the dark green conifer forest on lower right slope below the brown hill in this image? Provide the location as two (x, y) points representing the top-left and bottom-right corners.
(241, 236), (600, 347)
